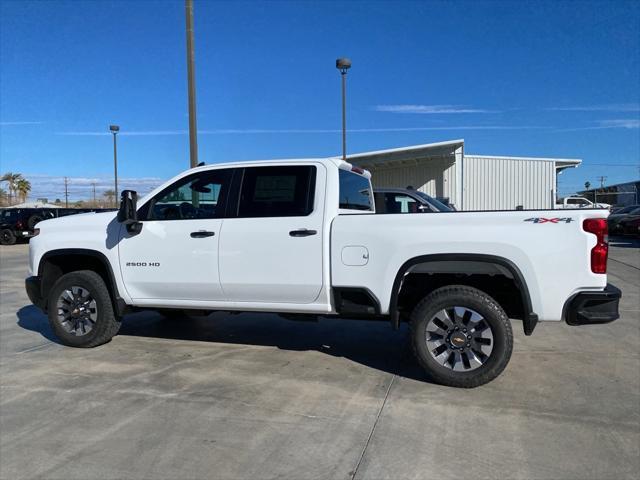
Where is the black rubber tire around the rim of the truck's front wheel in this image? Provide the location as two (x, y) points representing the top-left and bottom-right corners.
(47, 270), (121, 348)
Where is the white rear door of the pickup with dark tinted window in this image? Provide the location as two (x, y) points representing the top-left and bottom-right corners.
(219, 163), (326, 304)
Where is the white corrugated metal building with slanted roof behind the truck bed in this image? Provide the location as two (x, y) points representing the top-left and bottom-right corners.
(348, 140), (582, 210)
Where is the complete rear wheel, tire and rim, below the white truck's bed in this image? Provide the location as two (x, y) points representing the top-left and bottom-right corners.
(411, 285), (513, 388)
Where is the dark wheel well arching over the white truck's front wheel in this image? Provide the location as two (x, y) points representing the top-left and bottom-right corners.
(38, 252), (120, 312)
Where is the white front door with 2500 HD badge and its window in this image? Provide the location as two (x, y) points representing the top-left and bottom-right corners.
(118, 169), (231, 300)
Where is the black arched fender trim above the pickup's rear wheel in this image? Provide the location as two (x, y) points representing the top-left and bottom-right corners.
(389, 253), (538, 336)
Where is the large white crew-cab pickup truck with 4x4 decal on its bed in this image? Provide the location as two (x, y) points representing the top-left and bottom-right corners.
(26, 158), (620, 387)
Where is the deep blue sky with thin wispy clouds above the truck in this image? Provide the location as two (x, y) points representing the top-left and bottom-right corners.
(0, 0), (640, 199)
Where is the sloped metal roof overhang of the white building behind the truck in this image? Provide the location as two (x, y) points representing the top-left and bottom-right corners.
(347, 139), (464, 168)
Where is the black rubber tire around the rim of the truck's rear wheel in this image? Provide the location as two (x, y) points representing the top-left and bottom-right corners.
(410, 285), (513, 388)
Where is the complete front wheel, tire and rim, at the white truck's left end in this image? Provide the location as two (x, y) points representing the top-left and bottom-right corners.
(48, 270), (120, 347)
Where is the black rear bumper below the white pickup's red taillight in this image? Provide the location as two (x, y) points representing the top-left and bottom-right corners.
(564, 283), (622, 325)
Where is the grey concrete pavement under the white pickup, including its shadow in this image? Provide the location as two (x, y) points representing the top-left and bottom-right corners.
(0, 239), (640, 480)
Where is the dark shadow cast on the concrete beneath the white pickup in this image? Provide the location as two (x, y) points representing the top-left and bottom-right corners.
(17, 305), (429, 382)
